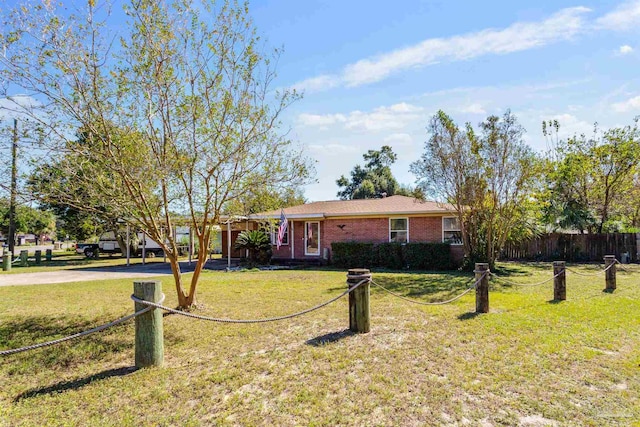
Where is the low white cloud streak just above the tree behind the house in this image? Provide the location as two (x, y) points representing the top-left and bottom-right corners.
(298, 102), (423, 132)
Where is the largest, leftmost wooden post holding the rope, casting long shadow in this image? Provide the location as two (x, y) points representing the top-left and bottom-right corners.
(133, 281), (164, 368)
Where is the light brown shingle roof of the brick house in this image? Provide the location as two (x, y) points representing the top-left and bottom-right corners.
(249, 196), (455, 219)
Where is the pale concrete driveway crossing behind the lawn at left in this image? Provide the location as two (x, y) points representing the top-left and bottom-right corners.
(0, 261), (226, 286)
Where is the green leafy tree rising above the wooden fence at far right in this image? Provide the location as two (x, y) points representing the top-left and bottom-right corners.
(543, 120), (640, 233)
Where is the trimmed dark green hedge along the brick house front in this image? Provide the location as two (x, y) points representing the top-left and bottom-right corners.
(331, 242), (456, 270)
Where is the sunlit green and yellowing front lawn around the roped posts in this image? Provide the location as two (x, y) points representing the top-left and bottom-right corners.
(0, 264), (640, 426)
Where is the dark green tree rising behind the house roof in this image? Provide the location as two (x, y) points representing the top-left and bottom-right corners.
(336, 145), (412, 200)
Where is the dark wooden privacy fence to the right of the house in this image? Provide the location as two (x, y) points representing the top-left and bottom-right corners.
(501, 233), (640, 262)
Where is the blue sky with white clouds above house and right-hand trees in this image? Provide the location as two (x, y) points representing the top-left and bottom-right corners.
(245, 0), (640, 201)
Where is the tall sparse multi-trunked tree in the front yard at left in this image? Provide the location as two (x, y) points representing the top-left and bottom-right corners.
(0, 0), (310, 308)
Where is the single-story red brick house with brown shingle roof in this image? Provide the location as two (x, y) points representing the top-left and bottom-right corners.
(222, 196), (463, 262)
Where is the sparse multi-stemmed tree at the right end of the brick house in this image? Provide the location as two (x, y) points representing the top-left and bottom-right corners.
(411, 111), (537, 266)
